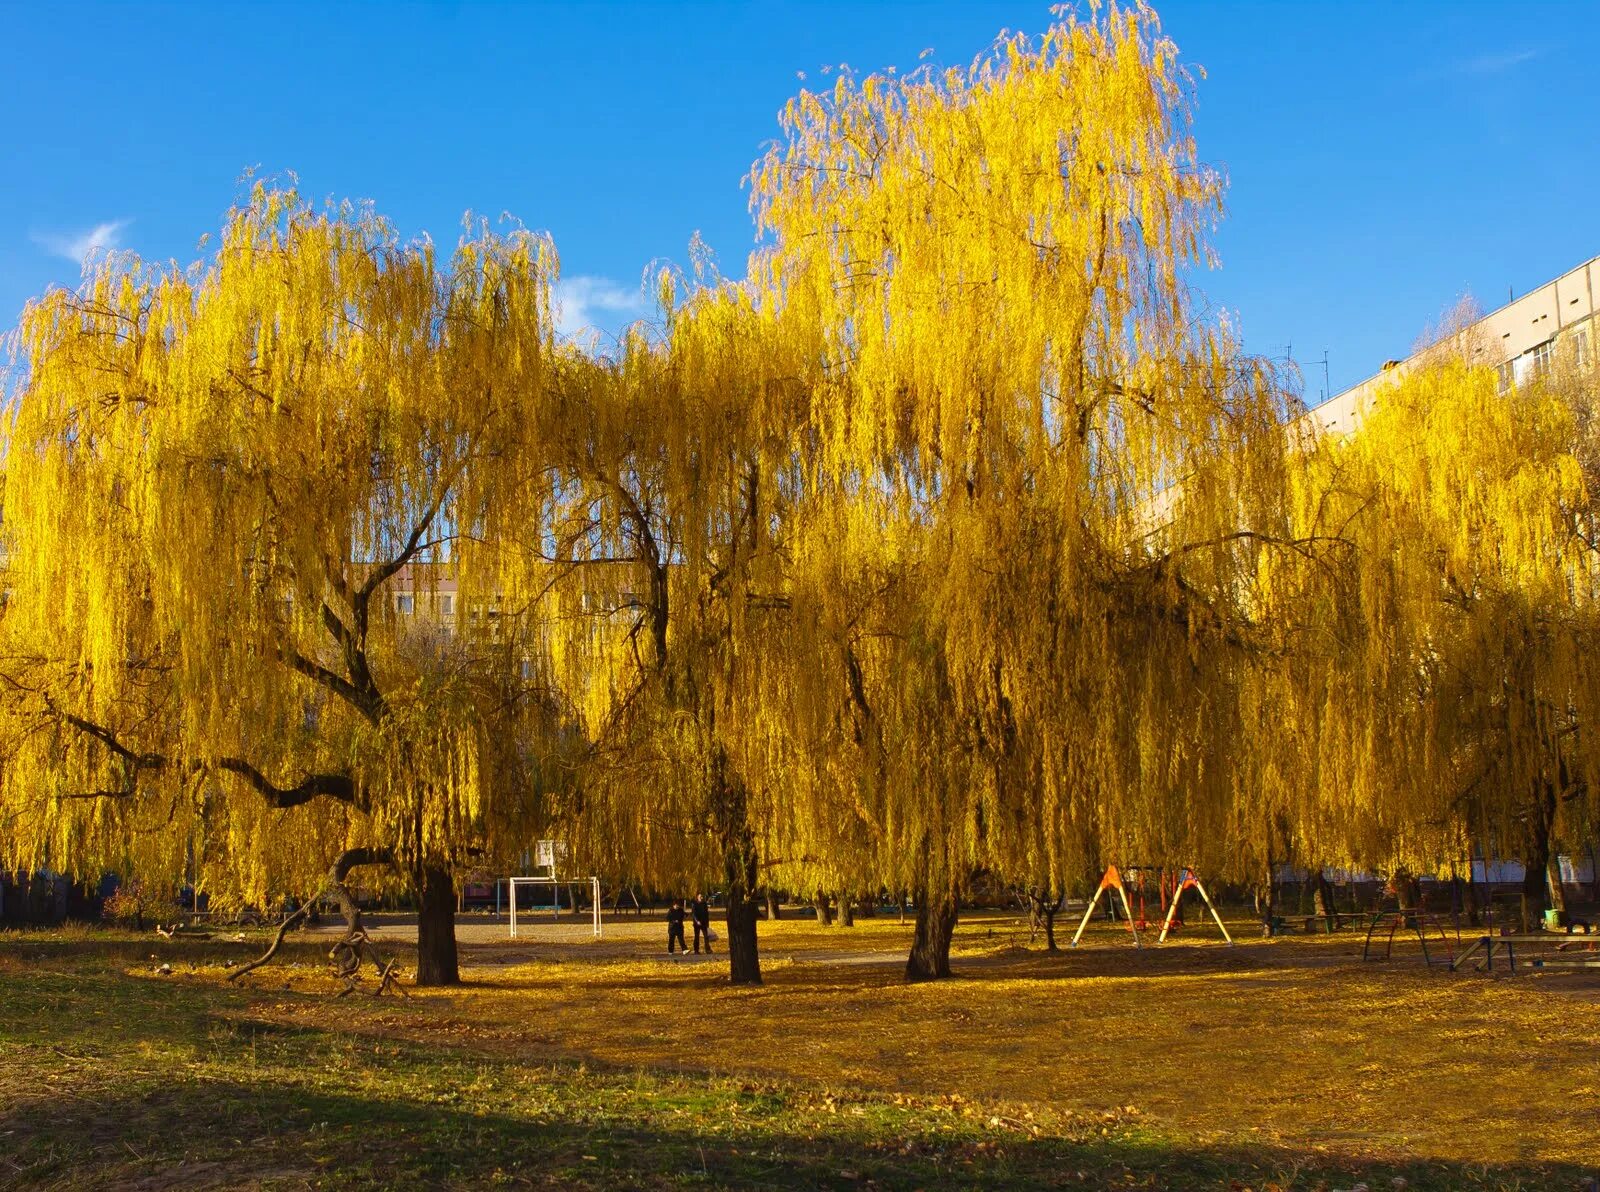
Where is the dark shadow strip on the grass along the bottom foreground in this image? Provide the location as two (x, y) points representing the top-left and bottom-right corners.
(0, 1072), (1584, 1192)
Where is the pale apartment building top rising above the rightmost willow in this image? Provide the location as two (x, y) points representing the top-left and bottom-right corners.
(1306, 256), (1600, 435)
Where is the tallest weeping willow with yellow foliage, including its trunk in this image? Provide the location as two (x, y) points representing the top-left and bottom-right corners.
(736, 8), (1315, 978)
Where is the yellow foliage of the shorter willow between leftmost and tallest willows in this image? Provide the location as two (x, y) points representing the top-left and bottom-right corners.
(498, 278), (805, 888)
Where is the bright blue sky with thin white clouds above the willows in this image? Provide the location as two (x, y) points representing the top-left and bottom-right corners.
(0, 0), (1600, 400)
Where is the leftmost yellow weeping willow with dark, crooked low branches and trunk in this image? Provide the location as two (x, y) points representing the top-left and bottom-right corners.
(0, 187), (565, 984)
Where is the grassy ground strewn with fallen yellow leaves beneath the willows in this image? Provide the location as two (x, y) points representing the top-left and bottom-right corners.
(0, 918), (1600, 1192)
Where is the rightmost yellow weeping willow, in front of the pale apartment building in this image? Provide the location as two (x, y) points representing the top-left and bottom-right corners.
(1285, 357), (1600, 928)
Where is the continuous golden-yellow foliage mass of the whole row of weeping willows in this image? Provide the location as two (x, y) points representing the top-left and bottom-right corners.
(9, 6), (1597, 934)
